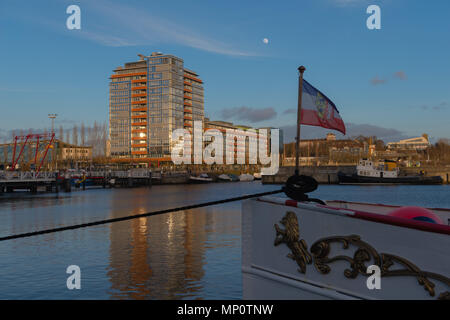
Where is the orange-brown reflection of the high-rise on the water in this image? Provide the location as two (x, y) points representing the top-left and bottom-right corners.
(108, 189), (211, 299)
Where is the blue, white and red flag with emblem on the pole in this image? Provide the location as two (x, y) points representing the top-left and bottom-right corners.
(301, 80), (345, 134)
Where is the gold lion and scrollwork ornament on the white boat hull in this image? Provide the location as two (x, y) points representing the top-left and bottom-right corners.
(274, 211), (450, 300)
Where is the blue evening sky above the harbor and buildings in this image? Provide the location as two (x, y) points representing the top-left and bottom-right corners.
(0, 0), (450, 142)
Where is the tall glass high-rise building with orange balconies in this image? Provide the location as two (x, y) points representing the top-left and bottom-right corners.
(109, 52), (204, 162)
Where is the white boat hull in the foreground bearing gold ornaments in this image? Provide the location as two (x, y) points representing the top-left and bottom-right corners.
(242, 200), (450, 299)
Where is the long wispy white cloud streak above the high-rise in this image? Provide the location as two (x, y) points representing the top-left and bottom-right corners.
(62, 0), (257, 56)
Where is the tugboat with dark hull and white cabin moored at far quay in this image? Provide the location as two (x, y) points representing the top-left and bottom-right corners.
(338, 159), (443, 184)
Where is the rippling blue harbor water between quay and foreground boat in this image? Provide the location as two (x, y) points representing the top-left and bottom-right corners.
(0, 181), (450, 299)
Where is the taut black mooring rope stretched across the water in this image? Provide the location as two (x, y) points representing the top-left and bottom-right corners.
(0, 190), (283, 241)
